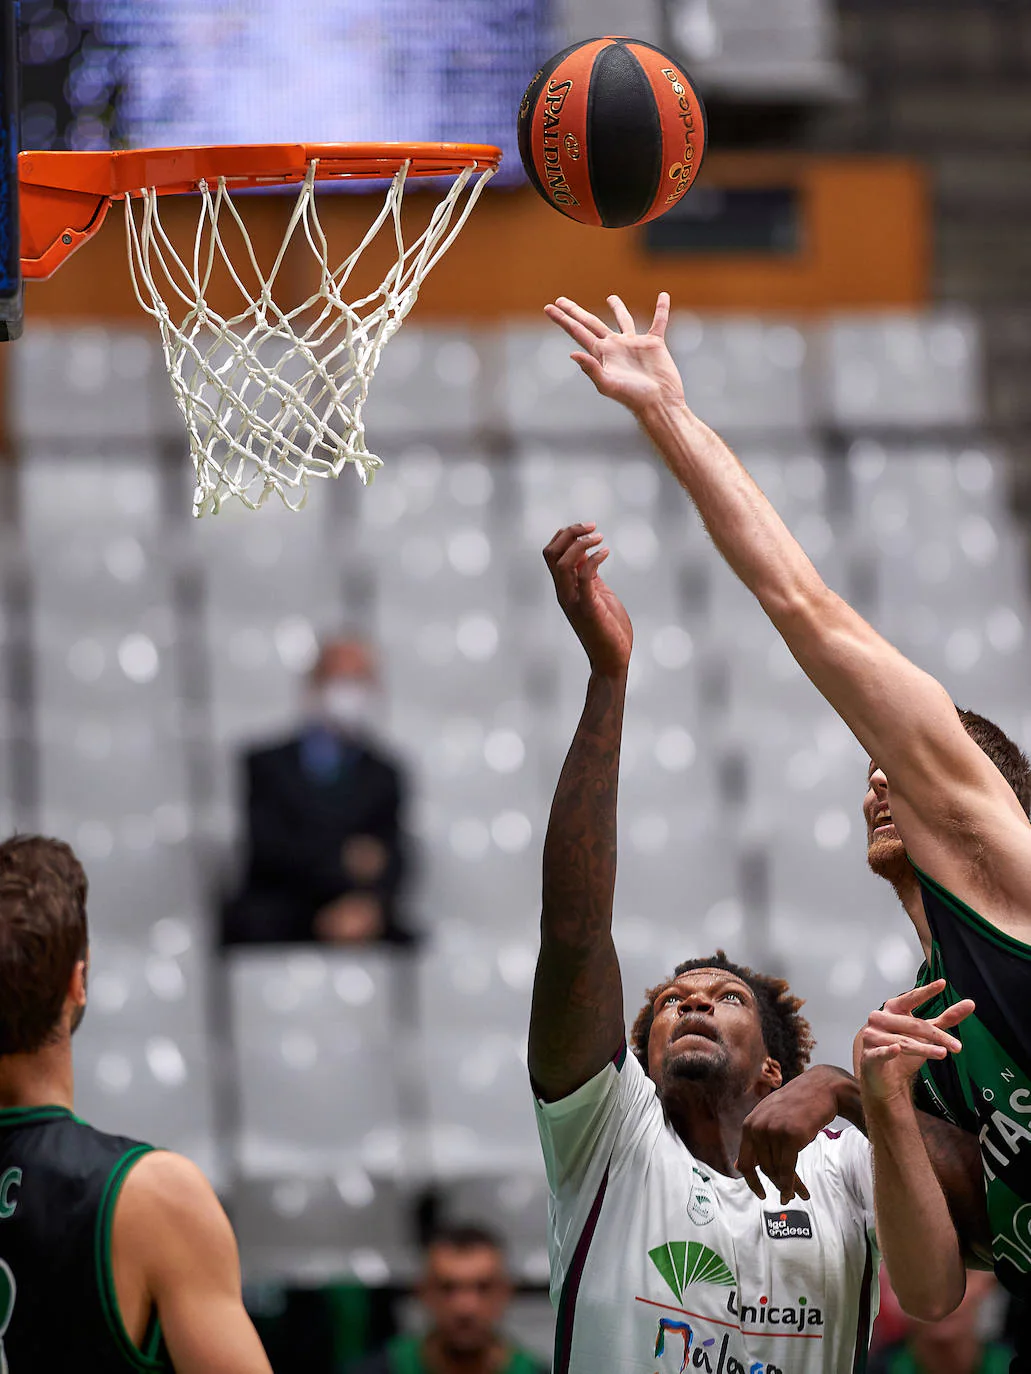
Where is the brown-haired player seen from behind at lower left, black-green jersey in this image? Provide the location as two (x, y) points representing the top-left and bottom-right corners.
(0, 835), (271, 1374)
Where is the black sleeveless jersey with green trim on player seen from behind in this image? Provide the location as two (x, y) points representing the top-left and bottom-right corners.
(0, 1106), (172, 1374)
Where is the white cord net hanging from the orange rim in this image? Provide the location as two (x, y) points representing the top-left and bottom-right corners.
(125, 161), (494, 515)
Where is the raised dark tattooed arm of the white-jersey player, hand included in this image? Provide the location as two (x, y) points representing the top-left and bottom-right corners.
(529, 523), (634, 1102)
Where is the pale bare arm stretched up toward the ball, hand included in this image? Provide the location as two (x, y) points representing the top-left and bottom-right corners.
(547, 293), (1031, 938)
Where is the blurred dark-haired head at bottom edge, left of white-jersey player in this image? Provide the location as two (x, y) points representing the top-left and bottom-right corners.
(418, 1226), (511, 1358)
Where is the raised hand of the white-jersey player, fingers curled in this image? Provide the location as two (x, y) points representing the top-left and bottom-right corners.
(544, 521), (634, 677)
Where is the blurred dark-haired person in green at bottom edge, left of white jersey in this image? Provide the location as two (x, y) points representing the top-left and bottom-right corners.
(351, 1226), (546, 1374)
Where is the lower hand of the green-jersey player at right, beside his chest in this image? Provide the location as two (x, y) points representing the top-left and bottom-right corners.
(856, 978), (973, 1102)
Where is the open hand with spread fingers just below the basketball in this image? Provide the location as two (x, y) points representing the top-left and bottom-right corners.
(544, 291), (685, 415)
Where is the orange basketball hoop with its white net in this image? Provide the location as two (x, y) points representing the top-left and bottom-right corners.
(18, 143), (500, 515)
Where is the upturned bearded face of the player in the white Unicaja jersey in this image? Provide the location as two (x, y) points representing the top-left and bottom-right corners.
(647, 969), (779, 1096)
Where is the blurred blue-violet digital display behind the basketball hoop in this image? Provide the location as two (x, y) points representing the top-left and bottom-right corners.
(76, 0), (553, 181)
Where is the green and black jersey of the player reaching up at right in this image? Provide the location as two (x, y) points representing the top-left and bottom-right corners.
(916, 870), (1031, 1298)
